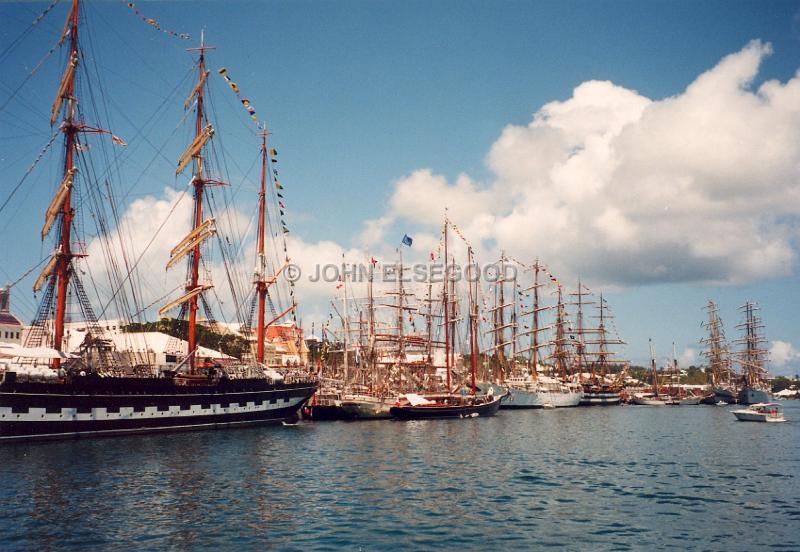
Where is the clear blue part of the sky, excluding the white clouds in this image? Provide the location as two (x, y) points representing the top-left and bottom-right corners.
(0, 1), (800, 372)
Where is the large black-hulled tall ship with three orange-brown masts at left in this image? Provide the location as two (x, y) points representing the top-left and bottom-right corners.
(0, 0), (317, 440)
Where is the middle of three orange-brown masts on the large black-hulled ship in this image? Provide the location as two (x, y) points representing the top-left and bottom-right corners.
(186, 32), (213, 374)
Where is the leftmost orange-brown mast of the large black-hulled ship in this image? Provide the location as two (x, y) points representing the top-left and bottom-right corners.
(53, 0), (78, 370)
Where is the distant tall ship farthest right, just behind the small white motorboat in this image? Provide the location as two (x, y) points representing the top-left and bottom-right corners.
(734, 301), (772, 404)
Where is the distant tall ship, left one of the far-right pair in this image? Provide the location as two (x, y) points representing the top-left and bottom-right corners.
(701, 300), (739, 404)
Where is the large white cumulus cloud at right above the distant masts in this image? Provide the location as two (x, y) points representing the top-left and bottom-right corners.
(367, 40), (800, 286)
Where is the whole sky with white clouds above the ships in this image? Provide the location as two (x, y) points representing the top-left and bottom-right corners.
(0, 1), (800, 374)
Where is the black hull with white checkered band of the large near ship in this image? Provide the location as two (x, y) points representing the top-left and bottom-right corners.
(0, 377), (316, 441)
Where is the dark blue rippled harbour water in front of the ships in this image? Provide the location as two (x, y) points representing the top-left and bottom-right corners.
(0, 401), (800, 550)
